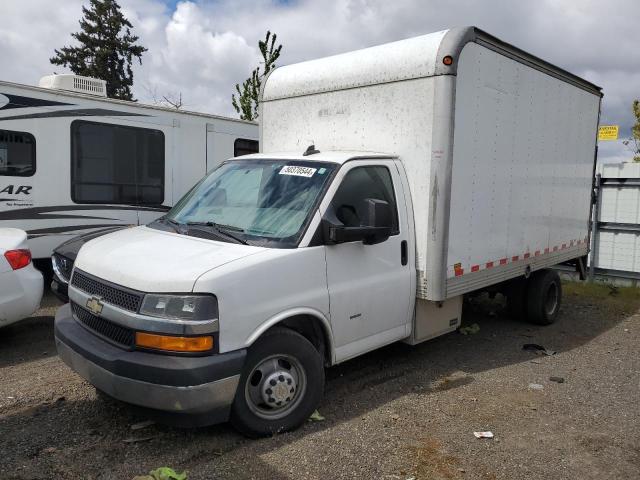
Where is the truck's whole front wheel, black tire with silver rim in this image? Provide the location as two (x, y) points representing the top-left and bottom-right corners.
(230, 328), (324, 437)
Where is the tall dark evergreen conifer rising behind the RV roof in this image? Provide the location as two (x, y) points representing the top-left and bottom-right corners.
(49, 0), (147, 100)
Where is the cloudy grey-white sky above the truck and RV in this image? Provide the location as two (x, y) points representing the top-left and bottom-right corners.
(0, 0), (640, 161)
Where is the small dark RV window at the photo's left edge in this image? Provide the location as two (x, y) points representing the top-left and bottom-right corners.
(0, 130), (36, 177)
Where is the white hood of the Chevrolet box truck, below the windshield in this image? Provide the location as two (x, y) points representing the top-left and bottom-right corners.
(75, 227), (266, 293)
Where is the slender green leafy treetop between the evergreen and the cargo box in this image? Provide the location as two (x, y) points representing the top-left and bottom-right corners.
(231, 31), (282, 120)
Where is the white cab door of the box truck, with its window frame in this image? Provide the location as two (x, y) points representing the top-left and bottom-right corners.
(325, 160), (412, 361)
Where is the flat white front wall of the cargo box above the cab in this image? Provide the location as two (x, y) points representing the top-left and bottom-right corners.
(260, 77), (434, 270)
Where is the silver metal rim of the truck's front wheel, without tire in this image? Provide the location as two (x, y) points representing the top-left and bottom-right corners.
(245, 355), (306, 420)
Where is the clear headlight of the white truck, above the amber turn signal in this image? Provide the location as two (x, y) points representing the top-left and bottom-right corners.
(140, 294), (218, 320)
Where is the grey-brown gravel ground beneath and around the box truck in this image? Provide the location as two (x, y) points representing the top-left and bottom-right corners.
(0, 285), (640, 480)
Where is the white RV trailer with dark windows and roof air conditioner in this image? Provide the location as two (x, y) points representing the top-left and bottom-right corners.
(0, 75), (258, 259)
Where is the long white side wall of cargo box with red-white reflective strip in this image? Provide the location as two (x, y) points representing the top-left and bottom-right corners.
(447, 43), (600, 297)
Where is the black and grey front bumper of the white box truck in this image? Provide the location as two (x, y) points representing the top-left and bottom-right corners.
(55, 305), (246, 424)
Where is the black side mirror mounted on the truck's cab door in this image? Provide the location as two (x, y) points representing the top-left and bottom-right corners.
(322, 198), (392, 245)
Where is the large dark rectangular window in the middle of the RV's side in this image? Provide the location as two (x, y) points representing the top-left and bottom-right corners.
(71, 120), (164, 205)
